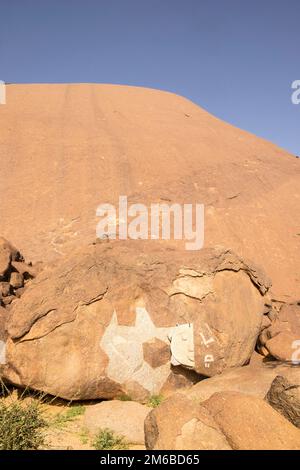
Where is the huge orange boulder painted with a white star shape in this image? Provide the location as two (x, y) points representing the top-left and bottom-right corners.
(4, 240), (269, 400)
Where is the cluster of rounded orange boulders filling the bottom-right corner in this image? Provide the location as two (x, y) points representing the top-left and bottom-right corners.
(145, 367), (300, 450)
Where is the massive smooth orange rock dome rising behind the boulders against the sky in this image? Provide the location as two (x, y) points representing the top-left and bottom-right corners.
(0, 84), (300, 302)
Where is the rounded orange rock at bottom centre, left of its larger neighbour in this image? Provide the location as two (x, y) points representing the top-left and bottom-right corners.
(145, 394), (231, 450)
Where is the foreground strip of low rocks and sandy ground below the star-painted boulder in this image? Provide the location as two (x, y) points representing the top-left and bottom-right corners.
(1, 354), (300, 450)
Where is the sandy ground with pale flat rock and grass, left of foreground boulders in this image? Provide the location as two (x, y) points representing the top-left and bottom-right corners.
(0, 389), (148, 450)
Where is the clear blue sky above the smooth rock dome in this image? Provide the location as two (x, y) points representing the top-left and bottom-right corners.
(0, 0), (300, 154)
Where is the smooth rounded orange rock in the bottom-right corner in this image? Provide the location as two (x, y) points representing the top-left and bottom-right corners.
(203, 392), (300, 450)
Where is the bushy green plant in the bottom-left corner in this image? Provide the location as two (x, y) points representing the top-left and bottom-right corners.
(0, 399), (47, 450)
